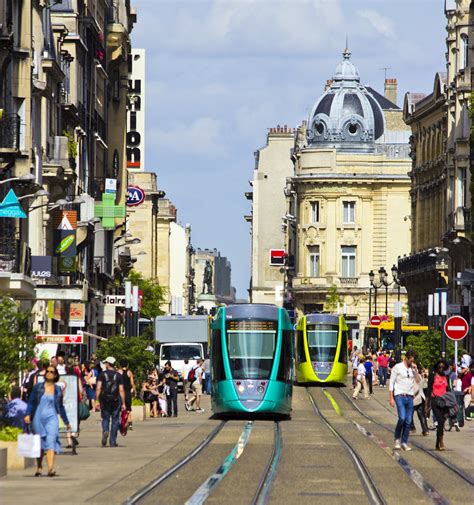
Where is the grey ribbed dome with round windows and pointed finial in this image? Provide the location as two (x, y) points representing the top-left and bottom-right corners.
(308, 49), (384, 151)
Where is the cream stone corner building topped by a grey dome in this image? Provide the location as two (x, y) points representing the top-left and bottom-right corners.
(285, 49), (410, 338)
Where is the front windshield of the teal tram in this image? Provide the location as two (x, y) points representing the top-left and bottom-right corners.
(227, 321), (277, 379)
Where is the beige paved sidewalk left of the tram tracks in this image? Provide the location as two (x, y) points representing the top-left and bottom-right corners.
(0, 395), (212, 505)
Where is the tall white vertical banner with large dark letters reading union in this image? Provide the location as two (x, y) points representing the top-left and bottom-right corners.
(127, 49), (145, 172)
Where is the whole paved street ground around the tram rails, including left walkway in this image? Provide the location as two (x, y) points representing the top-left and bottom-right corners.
(0, 387), (474, 505)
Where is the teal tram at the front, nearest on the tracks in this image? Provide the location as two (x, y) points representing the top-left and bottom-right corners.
(210, 303), (294, 416)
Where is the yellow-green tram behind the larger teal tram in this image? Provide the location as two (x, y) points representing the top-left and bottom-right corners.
(295, 314), (349, 384)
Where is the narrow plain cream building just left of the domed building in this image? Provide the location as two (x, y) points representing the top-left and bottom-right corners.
(245, 125), (295, 305)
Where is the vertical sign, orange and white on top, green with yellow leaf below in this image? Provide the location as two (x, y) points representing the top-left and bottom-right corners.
(53, 210), (77, 275)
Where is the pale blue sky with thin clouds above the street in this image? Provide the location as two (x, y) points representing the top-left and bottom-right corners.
(132, 0), (446, 298)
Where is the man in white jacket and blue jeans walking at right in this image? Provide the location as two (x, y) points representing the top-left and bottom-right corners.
(389, 351), (421, 451)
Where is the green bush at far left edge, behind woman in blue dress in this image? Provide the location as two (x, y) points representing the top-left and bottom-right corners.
(0, 298), (36, 398)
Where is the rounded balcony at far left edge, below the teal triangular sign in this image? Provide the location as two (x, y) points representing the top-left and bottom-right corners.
(0, 236), (35, 298)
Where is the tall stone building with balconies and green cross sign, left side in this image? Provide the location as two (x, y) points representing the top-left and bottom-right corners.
(0, 0), (136, 344)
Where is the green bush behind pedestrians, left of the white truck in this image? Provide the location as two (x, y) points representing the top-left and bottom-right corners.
(97, 335), (155, 387)
